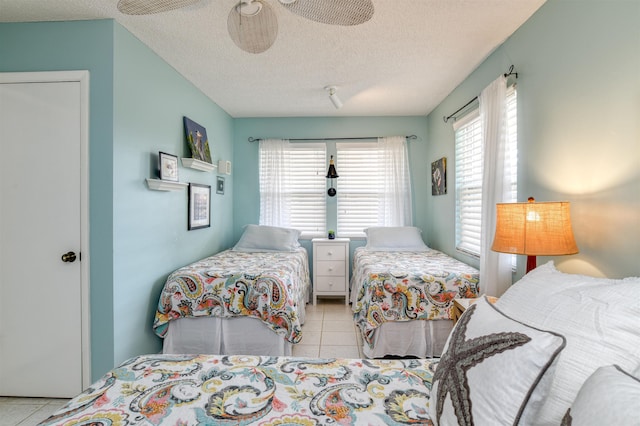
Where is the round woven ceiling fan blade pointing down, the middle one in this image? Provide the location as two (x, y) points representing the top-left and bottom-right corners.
(227, 0), (278, 53)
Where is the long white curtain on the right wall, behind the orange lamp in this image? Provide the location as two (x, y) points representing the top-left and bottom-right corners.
(478, 75), (511, 297)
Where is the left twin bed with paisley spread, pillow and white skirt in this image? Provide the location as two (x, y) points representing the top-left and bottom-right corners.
(158, 225), (310, 356)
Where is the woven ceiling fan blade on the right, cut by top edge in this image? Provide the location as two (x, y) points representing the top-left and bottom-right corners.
(280, 0), (373, 25)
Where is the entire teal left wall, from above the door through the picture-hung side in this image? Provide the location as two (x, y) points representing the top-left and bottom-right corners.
(0, 20), (233, 380)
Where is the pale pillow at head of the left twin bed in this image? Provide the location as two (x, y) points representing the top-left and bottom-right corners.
(233, 225), (300, 253)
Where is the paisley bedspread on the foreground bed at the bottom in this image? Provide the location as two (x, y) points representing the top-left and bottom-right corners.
(42, 355), (436, 426)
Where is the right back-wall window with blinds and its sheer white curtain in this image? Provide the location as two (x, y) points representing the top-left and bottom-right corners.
(336, 137), (412, 237)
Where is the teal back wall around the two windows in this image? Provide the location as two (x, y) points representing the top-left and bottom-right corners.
(233, 117), (431, 262)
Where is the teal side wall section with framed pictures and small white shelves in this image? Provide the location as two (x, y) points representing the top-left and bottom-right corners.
(113, 25), (233, 363)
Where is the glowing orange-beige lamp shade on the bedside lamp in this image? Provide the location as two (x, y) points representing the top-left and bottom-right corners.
(491, 198), (578, 256)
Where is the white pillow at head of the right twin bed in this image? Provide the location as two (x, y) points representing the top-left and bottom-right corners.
(364, 226), (429, 251)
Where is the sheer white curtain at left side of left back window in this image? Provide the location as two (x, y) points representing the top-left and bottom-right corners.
(259, 139), (290, 227)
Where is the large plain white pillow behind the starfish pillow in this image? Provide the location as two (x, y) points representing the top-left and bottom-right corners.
(496, 262), (640, 425)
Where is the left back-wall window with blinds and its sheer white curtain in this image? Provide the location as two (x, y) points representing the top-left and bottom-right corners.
(259, 140), (327, 238)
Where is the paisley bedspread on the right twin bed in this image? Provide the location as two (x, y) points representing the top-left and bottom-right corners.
(351, 247), (480, 347)
